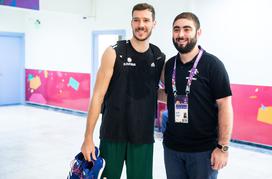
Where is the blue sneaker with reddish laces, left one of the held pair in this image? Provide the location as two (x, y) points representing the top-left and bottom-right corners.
(67, 147), (100, 179)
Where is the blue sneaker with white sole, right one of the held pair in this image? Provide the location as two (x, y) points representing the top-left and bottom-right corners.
(82, 157), (106, 179)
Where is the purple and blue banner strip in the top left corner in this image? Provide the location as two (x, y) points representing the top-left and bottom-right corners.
(0, 0), (39, 10)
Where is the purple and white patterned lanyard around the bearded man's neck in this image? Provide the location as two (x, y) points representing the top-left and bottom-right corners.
(172, 48), (204, 96)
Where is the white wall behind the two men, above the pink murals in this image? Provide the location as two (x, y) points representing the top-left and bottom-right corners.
(0, 0), (272, 86)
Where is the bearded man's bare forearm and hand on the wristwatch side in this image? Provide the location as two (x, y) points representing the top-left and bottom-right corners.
(211, 96), (233, 170)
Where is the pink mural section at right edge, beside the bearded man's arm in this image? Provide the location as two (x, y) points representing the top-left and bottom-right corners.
(231, 84), (272, 146)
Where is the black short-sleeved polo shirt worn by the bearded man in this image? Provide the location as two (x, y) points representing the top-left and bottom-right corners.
(164, 51), (231, 152)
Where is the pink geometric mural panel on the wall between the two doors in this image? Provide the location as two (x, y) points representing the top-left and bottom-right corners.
(26, 69), (90, 112)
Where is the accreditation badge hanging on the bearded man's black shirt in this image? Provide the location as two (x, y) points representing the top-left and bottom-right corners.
(175, 95), (188, 123)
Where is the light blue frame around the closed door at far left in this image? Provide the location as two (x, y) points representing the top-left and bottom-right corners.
(0, 31), (26, 106)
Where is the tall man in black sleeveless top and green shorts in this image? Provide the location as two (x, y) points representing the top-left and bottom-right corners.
(81, 3), (165, 179)
